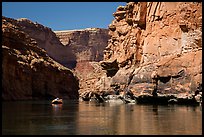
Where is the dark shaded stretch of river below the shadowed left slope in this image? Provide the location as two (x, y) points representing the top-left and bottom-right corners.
(2, 101), (78, 135)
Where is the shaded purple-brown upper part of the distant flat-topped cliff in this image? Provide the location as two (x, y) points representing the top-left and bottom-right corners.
(55, 28), (109, 62)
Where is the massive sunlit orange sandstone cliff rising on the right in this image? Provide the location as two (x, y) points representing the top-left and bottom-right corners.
(101, 2), (202, 96)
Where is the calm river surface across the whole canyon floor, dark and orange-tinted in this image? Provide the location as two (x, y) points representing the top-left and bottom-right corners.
(2, 100), (202, 135)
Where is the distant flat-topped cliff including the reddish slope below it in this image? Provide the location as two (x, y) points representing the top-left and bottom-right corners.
(55, 28), (110, 93)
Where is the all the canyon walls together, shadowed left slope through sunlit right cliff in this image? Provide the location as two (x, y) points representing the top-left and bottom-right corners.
(2, 2), (202, 100)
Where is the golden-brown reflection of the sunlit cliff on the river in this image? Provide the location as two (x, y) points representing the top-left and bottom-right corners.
(77, 103), (202, 135)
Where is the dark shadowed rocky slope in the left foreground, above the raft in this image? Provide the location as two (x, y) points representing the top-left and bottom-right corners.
(2, 17), (79, 100)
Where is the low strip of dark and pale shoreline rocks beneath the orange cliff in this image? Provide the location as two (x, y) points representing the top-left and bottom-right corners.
(79, 87), (202, 105)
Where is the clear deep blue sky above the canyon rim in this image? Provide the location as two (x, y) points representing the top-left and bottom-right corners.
(2, 2), (126, 31)
